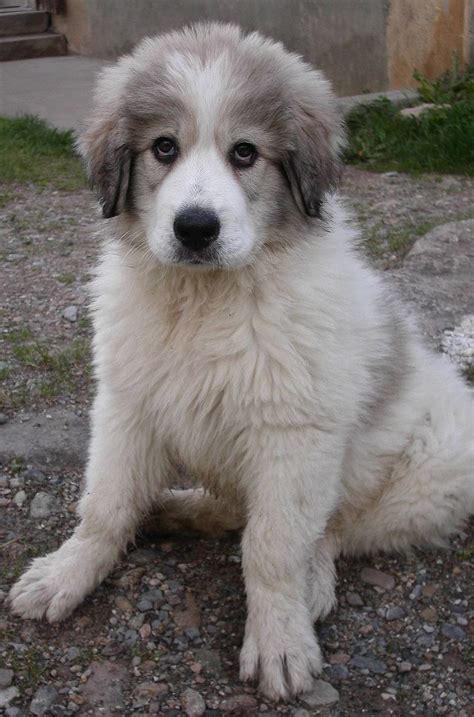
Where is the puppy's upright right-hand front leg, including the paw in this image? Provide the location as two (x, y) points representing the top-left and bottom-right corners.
(240, 429), (342, 699)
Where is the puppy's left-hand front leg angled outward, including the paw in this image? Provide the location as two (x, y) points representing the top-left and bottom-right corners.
(9, 393), (163, 622)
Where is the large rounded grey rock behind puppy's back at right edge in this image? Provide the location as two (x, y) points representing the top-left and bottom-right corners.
(392, 219), (474, 345)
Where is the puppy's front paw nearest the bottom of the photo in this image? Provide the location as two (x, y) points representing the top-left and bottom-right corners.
(240, 615), (322, 701)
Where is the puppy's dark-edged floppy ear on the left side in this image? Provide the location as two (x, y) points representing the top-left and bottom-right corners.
(77, 115), (132, 219)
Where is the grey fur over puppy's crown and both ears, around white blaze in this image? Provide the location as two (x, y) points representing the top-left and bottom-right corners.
(78, 23), (344, 217)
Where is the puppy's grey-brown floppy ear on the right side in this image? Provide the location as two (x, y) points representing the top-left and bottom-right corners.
(283, 79), (344, 217)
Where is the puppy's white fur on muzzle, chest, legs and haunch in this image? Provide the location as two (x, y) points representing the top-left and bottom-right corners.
(10, 25), (474, 699)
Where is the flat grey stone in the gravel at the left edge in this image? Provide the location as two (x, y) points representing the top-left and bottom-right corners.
(0, 408), (88, 470)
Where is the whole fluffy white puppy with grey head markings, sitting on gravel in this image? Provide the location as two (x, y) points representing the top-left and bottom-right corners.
(10, 24), (474, 699)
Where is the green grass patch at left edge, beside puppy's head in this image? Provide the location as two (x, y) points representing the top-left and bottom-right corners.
(0, 115), (86, 189)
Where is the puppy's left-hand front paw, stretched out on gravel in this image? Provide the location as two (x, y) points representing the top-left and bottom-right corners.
(8, 546), (94, 622)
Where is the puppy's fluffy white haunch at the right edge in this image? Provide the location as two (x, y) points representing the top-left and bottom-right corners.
(340, 376), (474, 554)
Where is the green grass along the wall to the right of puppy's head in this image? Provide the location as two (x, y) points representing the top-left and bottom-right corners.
(345, 66), (474, 176)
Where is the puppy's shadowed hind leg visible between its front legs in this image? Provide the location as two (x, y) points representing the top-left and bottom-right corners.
(145, 488), (244, 537)
